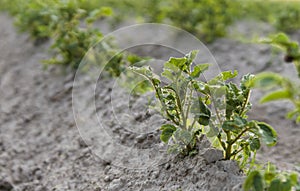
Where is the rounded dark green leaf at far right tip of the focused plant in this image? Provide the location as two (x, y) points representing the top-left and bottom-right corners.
(257, 122), (277, 146)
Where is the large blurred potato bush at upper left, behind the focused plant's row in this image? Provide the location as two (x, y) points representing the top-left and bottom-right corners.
(45, 1), (111, 69)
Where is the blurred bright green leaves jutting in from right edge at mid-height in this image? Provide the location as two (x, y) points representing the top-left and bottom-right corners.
(251, 33), (300, 123)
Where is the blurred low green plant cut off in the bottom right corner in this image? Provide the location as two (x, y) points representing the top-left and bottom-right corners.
(243, 163), (300, 191)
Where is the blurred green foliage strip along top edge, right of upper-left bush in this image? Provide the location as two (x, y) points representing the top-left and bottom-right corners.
(80, 0), (300, 42)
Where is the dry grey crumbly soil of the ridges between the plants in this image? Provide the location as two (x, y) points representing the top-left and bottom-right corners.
(0, 13), (300, 191)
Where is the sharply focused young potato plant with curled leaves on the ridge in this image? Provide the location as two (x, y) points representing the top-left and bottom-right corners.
(131, 51), (277, 165)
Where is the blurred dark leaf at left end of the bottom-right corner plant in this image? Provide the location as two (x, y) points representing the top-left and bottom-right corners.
(243, 170), (264, 191)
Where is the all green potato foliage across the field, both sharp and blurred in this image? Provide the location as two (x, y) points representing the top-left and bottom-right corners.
(0, 0), (300, 191)
